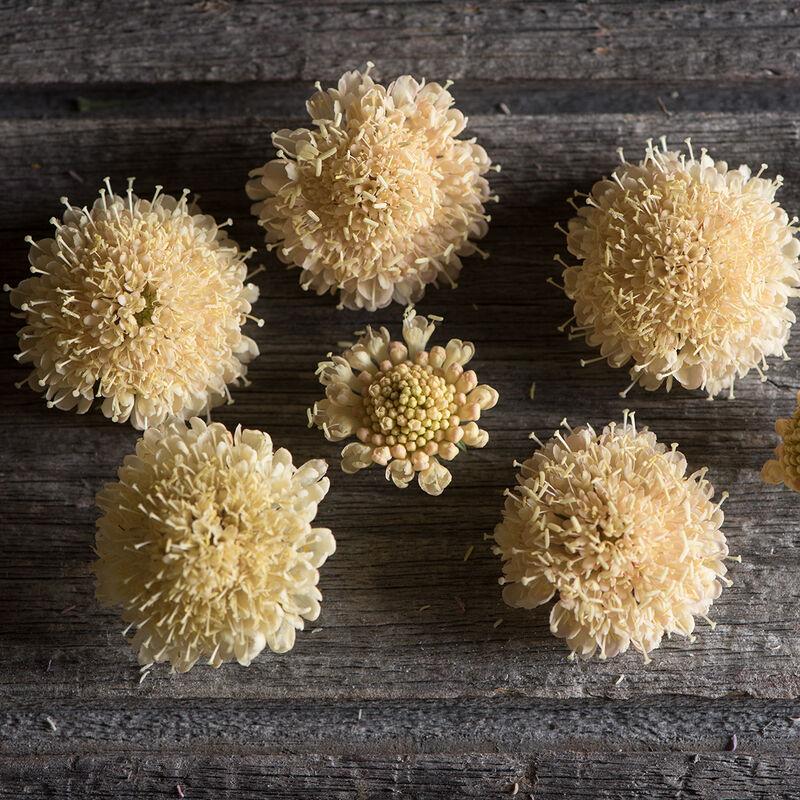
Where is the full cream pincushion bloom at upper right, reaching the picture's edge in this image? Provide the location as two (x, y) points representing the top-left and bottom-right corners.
(564, 139), (800, 397)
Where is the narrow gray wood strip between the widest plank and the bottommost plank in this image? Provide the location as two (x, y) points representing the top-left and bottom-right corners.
(0, 695), (800, 758)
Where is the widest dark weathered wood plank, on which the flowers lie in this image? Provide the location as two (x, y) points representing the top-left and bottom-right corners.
(0, 113), (800, 703)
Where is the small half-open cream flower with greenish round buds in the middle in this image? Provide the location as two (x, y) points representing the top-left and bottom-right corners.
(309, 309), (497, 495)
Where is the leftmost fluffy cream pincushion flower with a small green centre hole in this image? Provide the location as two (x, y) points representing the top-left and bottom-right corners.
(6, 179), (260, 429)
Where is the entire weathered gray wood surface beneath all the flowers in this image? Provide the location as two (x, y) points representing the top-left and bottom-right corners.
(0, 0), (800, 800)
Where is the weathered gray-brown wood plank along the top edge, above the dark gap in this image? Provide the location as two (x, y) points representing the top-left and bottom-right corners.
(0, 0), (800, 85)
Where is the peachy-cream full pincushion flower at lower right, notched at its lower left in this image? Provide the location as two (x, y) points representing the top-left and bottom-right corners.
(494, 412), (729, 660)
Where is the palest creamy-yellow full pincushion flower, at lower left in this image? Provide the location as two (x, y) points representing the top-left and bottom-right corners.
(94, 417), (336, 672)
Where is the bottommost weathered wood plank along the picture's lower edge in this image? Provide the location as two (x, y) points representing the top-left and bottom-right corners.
(0, 750), (800, 800)
